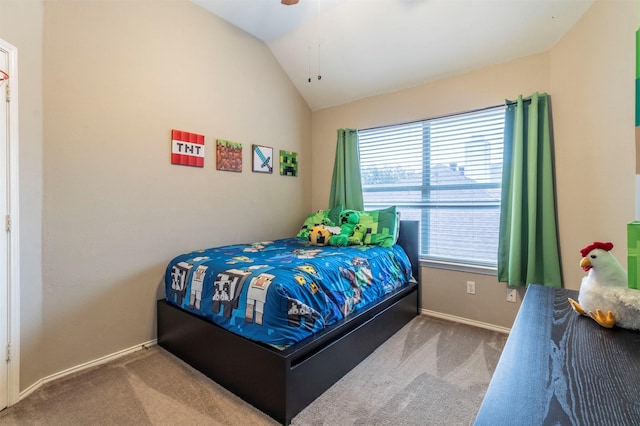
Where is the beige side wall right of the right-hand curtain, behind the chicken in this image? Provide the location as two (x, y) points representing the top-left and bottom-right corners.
(551, 0), (638, 289)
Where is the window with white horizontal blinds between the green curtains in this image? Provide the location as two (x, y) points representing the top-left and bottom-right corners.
(359, 106), (504, 267)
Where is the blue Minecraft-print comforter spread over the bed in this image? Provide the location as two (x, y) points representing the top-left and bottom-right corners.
(165, 238), (411, 347)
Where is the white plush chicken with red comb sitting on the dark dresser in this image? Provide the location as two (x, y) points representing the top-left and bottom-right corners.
(569, 242), (640, 330)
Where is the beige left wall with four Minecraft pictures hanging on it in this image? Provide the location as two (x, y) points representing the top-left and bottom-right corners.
(0, 0), (311, 390)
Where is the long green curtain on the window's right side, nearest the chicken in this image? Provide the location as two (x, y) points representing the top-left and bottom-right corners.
(498, 93), (562, 287)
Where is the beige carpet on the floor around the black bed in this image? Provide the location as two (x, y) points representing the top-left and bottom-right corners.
(0, 316), (507, 426)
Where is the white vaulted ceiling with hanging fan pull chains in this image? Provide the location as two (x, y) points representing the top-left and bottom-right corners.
(192, 0), (594, 111)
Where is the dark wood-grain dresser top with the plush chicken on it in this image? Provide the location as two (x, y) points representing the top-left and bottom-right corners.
(475, 285), (640, 426)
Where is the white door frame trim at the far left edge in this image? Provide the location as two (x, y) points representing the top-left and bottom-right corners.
(0, 39), (20, 406)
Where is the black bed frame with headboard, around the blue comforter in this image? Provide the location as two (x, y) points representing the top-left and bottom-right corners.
(157, 221), (419, 425)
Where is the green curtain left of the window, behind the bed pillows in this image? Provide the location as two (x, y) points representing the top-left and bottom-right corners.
(329, 129), (364, 210)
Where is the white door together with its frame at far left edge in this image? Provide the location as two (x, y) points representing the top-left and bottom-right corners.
(0, 40), (19, 410)
